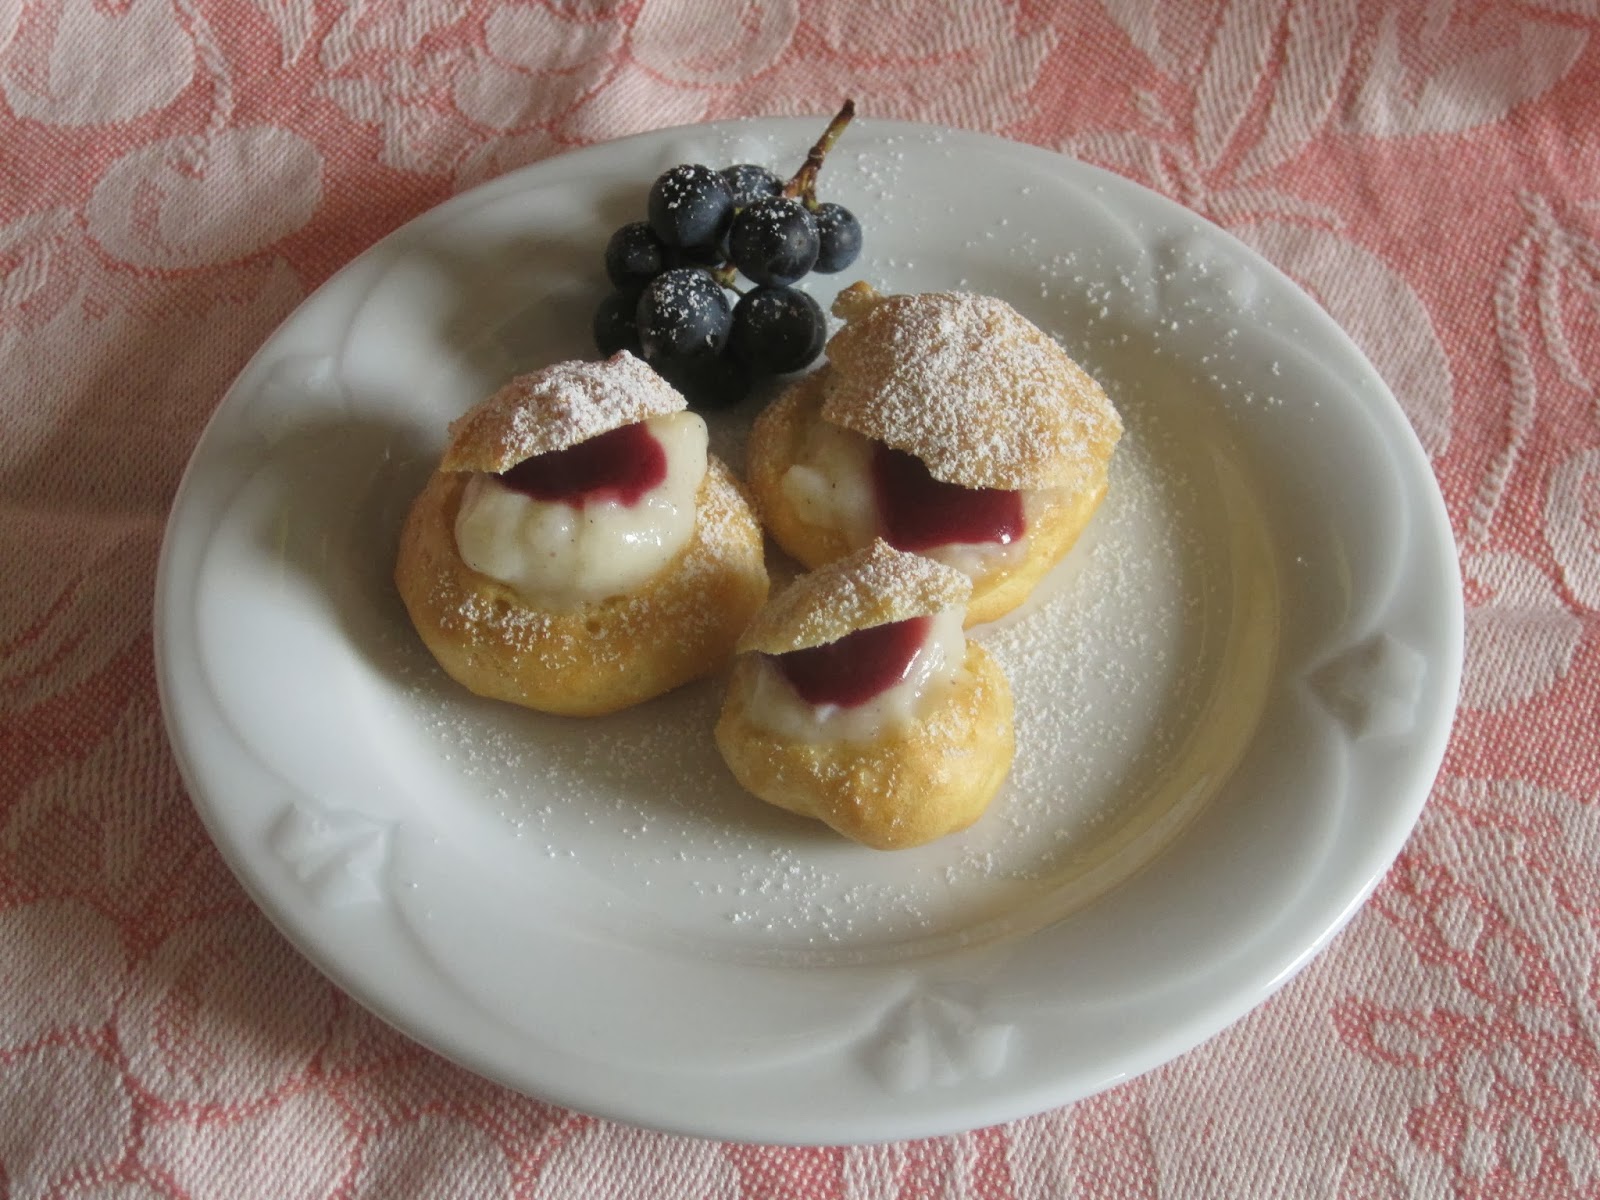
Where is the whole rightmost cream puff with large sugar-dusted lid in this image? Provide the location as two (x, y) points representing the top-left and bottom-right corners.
(749, 283), (1122, 624)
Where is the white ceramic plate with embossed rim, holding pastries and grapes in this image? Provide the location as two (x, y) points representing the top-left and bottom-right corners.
(157, 120), (1462, 1142)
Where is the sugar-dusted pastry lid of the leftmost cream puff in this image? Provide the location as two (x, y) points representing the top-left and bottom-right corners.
(438, 350), (688, 474)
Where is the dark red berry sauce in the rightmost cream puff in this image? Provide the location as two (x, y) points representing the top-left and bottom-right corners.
(872, 442), (1026, 552)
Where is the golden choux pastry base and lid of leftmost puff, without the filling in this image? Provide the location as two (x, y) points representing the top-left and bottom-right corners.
(395, 352), (768, 717)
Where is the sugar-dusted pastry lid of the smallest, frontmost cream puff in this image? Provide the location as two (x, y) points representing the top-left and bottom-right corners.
(738, 539), (973, 654)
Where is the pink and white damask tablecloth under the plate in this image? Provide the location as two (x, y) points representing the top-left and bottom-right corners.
(0, 0), (1600, 1200)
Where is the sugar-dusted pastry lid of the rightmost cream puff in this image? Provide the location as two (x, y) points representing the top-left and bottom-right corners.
(822, 283), (1122, 491)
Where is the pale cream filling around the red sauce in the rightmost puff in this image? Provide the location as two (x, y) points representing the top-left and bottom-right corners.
(779, 421), (1051, 582)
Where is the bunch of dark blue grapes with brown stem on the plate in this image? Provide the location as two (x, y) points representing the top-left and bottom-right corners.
(594, 101), (861, 408)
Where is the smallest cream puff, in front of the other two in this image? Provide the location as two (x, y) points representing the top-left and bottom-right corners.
(717, 539), (1016, 850)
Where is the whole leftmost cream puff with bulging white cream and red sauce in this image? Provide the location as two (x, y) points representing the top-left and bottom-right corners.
(395, 352), (768, 715)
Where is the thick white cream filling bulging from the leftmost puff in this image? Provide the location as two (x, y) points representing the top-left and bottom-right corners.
(456, 413), (706, 610)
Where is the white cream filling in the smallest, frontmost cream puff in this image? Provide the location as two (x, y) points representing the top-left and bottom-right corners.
(746, 608), (966, 742)
